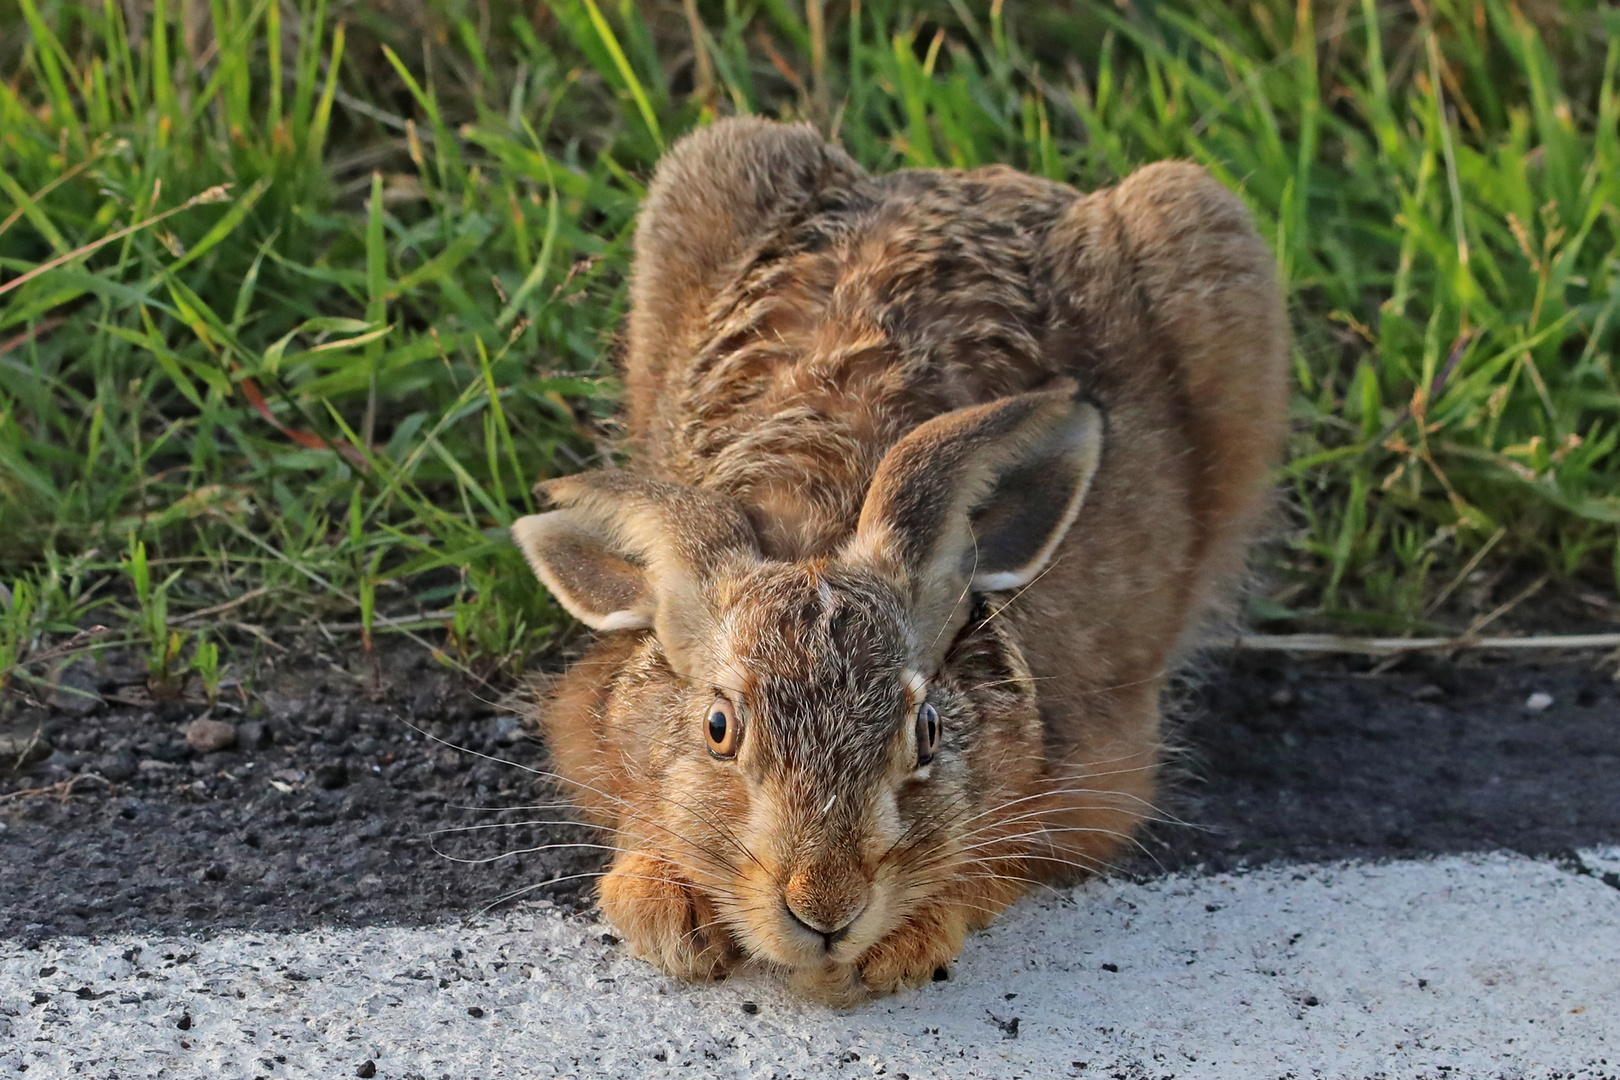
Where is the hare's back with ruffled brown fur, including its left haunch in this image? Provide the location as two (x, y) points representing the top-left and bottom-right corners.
(627, 120), (1077, 554)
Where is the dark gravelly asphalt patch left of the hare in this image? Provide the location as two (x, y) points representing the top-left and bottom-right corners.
(0, 648), (601, 938)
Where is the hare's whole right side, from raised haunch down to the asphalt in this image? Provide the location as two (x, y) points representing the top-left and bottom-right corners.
(1013, 162), (1288, 870)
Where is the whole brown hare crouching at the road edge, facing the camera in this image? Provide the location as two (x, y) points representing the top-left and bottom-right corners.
(512, 118), (1288, 1004)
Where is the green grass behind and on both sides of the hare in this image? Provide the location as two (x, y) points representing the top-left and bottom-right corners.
(0, 0), (1620, 693)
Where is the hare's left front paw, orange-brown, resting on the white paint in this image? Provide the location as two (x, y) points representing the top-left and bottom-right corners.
(601, 853), (742, 980)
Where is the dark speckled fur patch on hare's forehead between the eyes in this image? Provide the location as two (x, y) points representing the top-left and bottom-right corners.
(723, 565), (907, 782)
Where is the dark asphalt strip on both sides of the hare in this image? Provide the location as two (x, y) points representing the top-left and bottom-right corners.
(0, 651), (1620, 939)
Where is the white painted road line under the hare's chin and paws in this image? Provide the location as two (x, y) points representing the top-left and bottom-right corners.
(0, 852), (1620, 1080)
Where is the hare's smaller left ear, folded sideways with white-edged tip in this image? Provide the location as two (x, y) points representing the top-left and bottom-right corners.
(512, 470), (758, 663)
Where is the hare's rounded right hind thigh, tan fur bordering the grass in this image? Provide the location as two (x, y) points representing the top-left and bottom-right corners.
(1053, 162), (1288, 615)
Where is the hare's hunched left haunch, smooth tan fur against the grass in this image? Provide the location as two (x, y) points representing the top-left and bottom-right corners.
(627, 117), (862, 442)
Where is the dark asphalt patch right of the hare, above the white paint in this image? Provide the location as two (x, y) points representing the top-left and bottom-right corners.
(1145, 653), (1620, 871)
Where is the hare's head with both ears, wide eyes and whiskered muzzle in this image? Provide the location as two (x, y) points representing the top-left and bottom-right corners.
(514, 385), (1102, 968)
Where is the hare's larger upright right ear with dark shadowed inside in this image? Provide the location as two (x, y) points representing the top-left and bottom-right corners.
(844, 381), (1103, 663)
